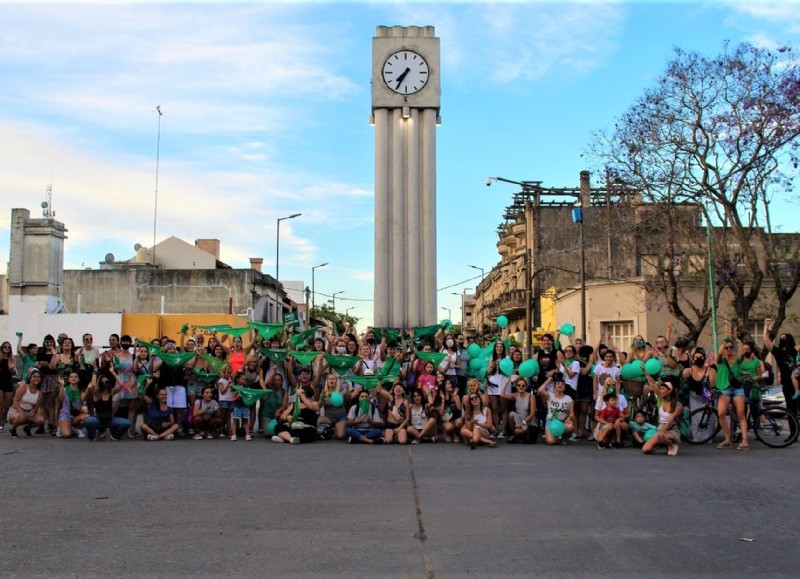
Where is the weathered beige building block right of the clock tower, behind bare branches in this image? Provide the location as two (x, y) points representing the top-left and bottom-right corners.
(465, 173), (800, 349)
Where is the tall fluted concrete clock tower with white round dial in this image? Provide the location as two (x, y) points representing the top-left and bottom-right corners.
(372, 26), (441, 328)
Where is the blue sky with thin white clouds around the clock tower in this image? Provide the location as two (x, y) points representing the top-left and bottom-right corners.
(0, 2), (800, 323)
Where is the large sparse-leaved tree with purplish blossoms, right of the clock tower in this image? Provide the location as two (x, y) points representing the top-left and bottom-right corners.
(589, 43), (800, 335)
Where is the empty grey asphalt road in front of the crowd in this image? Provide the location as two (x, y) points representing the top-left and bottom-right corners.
(0, 432), (800, 577)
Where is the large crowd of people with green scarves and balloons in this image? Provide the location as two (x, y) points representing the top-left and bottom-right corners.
(0, 321), (800, 456)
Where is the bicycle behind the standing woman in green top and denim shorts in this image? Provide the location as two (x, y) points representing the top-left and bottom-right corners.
(682, 386), (800, 448)
